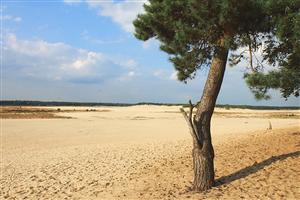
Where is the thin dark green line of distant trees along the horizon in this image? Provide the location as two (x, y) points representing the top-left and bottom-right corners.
(0, 100), (300, 110)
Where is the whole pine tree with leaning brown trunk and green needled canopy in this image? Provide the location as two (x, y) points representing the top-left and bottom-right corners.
(134, 0), (300, 191)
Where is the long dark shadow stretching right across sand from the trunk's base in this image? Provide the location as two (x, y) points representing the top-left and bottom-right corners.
(215, 151), (300, 186)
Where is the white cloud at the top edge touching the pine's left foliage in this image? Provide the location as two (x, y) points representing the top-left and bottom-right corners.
(86, 0), (147, 32)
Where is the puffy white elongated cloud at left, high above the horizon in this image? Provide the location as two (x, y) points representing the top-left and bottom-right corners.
(3, 34), (136, 83)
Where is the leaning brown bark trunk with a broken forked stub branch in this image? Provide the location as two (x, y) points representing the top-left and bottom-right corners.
(181, 40), (228, 191)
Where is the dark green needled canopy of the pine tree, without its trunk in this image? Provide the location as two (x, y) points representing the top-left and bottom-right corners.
(134, 0), (300, 99)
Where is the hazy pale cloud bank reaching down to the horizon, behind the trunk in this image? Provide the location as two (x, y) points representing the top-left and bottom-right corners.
(2, 34), (299, 105)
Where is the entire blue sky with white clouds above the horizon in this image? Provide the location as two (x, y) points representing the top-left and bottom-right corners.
(1, 0), (300, 106)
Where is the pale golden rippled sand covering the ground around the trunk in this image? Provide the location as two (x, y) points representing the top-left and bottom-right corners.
(0, 106), (300, 199)
